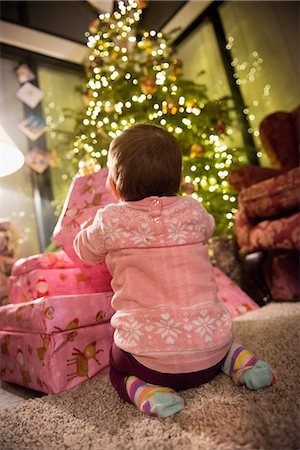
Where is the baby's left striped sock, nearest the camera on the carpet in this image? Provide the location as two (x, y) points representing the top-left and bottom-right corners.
(126, 375), (184, 418)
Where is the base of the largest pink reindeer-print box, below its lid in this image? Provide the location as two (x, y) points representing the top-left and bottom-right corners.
(0, 323), (112, 394)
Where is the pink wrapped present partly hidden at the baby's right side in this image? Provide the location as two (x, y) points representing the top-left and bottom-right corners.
(214, 267), (259, 318)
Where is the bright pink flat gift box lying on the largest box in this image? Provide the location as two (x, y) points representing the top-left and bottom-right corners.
(9, 251), (111, 303)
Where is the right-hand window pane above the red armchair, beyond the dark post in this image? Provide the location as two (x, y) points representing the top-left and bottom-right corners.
(220, 1), (300, 164)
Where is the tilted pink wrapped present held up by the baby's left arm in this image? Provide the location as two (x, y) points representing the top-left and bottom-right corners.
(53, 168), (116, 291)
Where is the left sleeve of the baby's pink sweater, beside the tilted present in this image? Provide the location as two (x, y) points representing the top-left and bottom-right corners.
(73, 210), (107, 264)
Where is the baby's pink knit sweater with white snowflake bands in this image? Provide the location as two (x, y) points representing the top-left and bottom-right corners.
(74, 196), (232, 373)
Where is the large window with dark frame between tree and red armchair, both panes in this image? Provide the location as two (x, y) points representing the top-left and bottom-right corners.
(178, 1), (300, 165)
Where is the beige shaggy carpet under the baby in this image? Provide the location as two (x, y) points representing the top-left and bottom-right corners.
(0, 303), (300, 450)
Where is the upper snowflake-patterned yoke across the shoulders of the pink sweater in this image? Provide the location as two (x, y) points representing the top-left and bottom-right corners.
(89, 197), (214, 250)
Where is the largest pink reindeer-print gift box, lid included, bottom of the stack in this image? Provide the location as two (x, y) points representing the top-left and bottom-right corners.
(0, 291), (113, 393)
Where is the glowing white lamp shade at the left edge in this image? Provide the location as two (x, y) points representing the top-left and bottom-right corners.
(0, 124), (25, 177)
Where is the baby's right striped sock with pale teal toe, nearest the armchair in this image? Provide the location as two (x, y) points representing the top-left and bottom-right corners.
(222, 343), (276, 390)
